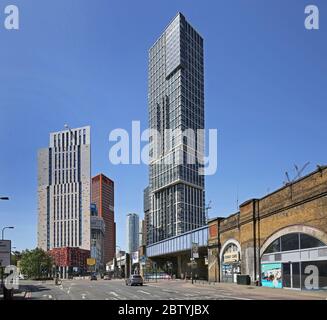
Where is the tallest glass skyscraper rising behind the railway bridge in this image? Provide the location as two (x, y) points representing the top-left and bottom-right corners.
(147, 13), (205, 243)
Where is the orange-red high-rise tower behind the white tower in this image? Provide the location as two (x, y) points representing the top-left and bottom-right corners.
(92, 174), (116, 263)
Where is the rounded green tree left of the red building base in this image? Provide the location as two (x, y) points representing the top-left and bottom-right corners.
(20, 248), (53, 279)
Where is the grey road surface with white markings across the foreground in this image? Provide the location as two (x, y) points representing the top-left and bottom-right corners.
(4, 279), (327, 300)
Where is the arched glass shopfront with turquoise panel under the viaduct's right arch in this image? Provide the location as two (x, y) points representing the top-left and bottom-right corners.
(261, 233), (327, 290)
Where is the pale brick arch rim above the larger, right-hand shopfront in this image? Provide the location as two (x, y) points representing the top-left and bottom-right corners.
(260, 225), (327, 257)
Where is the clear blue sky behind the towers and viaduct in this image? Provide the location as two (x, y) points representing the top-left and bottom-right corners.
(0, 0), (327, 249)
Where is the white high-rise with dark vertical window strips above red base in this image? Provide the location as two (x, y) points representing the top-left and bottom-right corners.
(38, 127), (91, 250)
